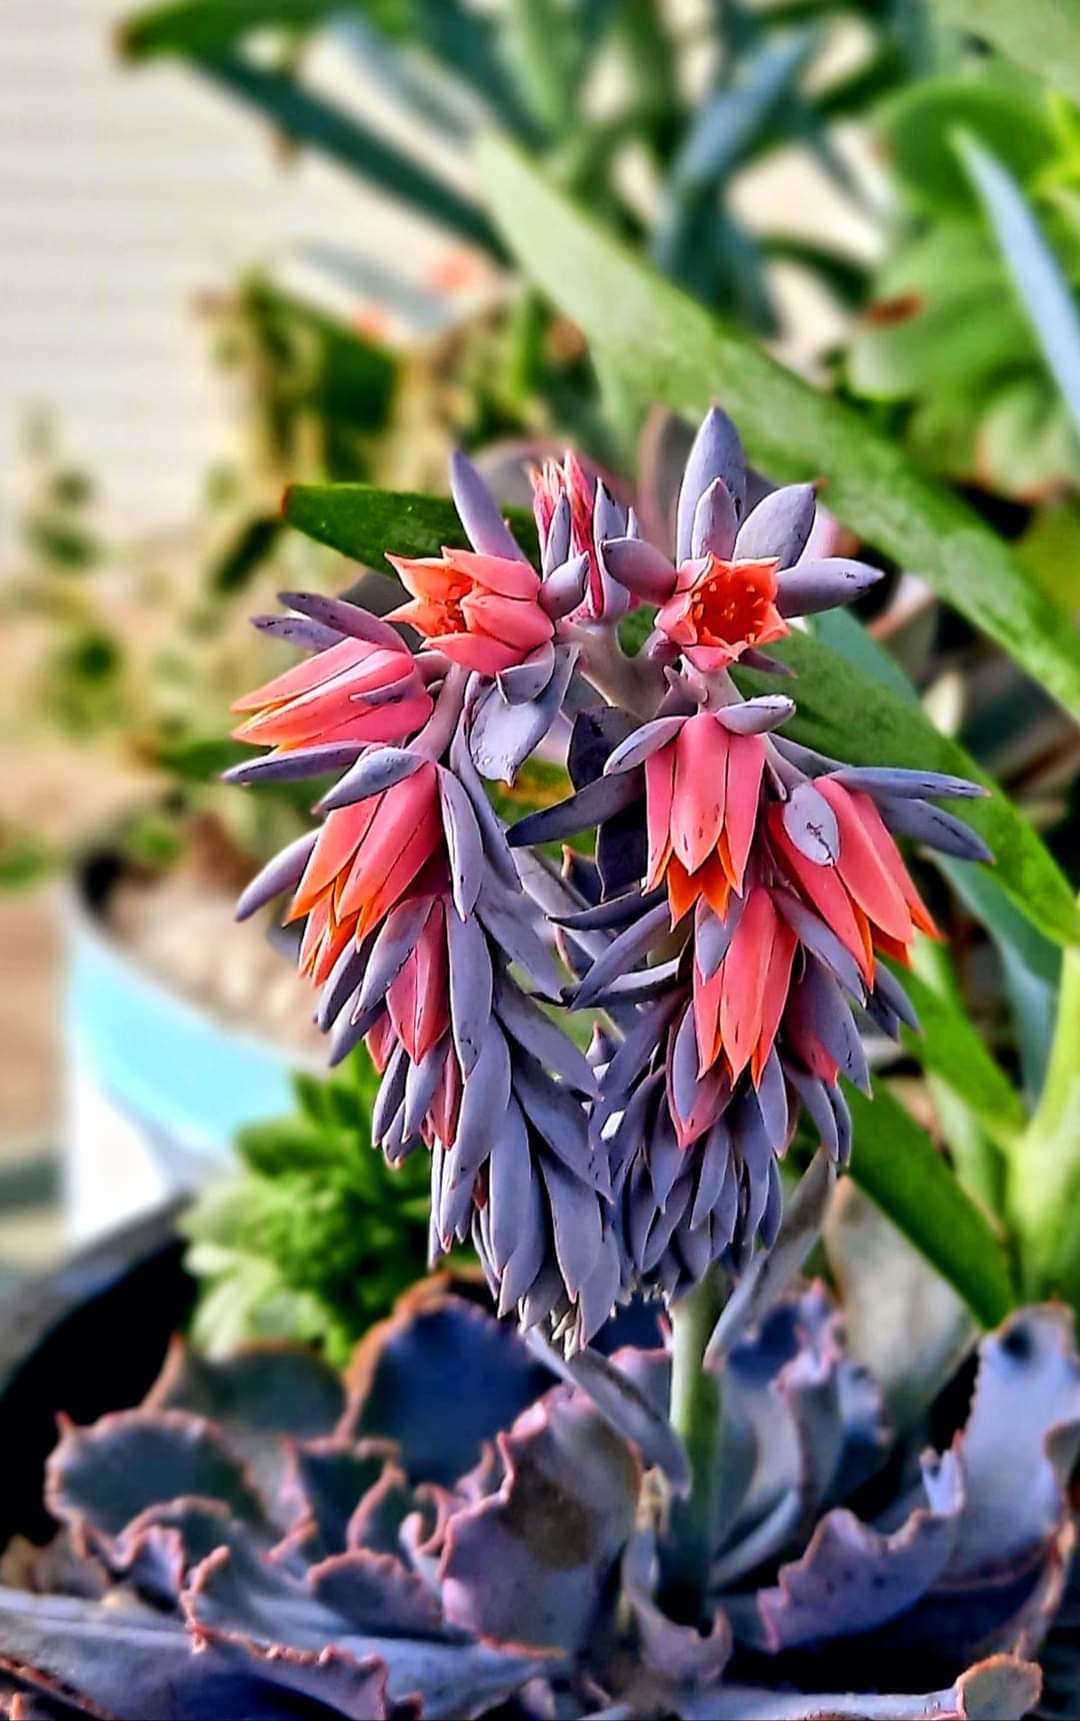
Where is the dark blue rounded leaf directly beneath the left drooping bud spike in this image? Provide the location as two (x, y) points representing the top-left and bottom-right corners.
(351, 1291), (547, 1487)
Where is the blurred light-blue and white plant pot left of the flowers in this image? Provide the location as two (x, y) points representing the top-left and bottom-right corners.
(64, 854), (311, 1243)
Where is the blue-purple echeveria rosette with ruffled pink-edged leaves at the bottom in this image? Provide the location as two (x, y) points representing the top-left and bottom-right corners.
(0, 1286), (1080, 1721)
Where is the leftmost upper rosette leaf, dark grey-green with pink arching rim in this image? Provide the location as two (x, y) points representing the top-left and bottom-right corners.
(46, 1411), (267, 1537)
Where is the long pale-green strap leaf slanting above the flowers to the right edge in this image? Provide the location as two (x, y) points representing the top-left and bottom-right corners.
(480, 138), (1080, 716)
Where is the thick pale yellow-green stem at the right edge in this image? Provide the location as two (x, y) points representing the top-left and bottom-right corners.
(1008, 908), (1080, 1303)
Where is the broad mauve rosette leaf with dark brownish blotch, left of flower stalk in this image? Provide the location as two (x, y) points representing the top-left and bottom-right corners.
(442, 1389), (641, 1654)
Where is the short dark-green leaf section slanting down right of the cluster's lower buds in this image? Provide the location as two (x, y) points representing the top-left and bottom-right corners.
(844, 1083), (1016, 1327)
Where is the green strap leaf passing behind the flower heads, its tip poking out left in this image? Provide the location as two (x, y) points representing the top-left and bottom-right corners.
(284, 484), (1080, 943)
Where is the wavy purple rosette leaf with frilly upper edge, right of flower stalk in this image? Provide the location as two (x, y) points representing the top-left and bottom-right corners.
(752, 1453), (963, 1652)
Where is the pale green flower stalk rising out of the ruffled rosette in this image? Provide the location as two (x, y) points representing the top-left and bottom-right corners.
(664, 1275), (722, 1625)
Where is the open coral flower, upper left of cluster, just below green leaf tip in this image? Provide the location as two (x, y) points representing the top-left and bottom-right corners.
(387, 549), (554, 675)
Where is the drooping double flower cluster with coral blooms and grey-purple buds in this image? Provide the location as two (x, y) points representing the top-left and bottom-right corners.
(232, 410), (987, 1349)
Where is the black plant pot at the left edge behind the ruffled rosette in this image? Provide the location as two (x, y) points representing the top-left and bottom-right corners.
(0, 1201), (194, 1549)
